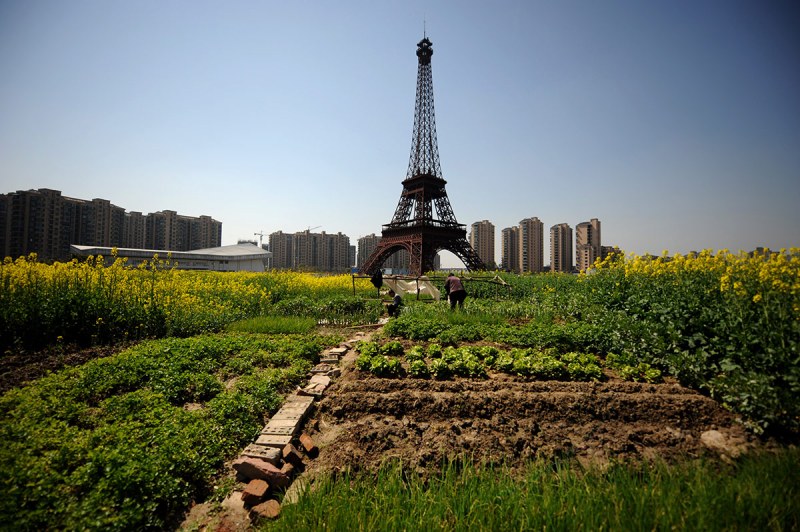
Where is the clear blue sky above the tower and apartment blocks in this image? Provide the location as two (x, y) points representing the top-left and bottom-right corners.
(0, 0), (800, 266)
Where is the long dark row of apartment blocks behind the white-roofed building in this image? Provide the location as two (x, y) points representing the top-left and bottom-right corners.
(0, 189), (222, 261)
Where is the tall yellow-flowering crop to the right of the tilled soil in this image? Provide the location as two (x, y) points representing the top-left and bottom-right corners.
(581, 248), (800, 430)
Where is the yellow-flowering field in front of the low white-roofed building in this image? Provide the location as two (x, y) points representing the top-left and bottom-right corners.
(0, 255), (374, 349)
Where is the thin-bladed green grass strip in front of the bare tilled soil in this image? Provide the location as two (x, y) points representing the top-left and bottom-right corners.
(262, 449), (800, 531)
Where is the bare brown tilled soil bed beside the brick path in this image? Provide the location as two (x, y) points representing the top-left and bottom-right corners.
(308, 367), (757, 472)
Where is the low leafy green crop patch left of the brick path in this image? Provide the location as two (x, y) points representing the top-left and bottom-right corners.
(0, 333), (338, 530)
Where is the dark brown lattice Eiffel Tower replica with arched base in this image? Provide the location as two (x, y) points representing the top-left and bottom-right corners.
(360, 36), (485, 277)
